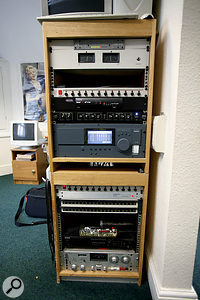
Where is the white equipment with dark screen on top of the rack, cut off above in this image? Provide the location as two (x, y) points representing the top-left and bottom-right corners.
(41, 0), (152, 18)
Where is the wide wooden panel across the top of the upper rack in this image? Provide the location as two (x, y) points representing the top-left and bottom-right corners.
(42, 19), (156, 39)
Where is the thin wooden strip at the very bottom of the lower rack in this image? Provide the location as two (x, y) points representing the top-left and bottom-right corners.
(59, 270), (139, 278)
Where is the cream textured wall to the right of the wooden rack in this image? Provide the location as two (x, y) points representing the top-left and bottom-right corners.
(146, 0), (200, 299)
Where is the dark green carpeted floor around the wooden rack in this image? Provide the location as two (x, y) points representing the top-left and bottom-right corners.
(0, 175), (152, 300)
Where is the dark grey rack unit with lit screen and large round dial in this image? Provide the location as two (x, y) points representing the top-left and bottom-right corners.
(52, 123), (146, 158)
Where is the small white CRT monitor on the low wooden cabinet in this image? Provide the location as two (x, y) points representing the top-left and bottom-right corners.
(11, 121), (41, 147)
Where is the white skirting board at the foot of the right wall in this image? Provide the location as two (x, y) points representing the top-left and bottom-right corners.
(146, 249), (198, 300)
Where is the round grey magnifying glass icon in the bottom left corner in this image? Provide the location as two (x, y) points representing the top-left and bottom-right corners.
(2, 276), (24, 298)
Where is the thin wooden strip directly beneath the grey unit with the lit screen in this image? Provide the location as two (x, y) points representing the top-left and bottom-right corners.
(52, 157), (146, 164)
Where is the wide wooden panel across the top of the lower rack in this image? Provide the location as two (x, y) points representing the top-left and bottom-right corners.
(51, 168), (148, 186)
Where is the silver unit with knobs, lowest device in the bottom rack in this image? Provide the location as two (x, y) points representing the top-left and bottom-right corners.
(61, 248), (138, 272)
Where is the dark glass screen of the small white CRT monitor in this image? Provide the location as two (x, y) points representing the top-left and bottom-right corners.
(13, 123), (34, 141)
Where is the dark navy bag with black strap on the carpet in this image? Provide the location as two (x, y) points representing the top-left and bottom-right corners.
(15, 187), (47, 227)
